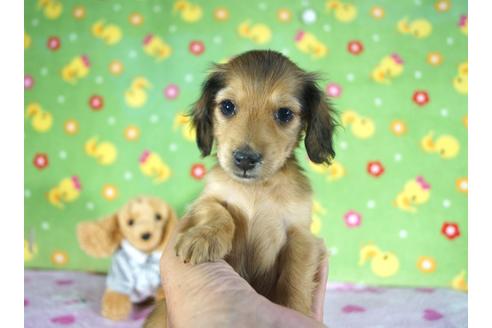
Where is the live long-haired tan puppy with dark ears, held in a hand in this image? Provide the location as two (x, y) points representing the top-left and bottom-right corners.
(146, 51), (335, 327)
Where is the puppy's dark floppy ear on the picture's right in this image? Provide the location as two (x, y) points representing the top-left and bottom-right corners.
(301, 74), (337, 164)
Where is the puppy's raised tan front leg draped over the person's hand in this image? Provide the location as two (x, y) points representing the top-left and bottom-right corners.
(175, 197), (235, 264)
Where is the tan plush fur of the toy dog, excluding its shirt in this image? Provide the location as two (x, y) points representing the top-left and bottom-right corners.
(77, 197), (177, 320)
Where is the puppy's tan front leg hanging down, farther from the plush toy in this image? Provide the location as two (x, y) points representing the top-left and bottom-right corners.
(274, 227), (326, 317)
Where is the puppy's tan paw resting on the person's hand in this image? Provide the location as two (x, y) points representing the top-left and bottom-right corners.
(174, 226), (232, 264)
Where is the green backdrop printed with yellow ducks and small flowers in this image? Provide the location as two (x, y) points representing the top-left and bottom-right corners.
(24, 0), (468, 289)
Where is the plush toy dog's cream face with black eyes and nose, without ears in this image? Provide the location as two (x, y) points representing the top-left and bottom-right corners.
(118, 198), (172, 252)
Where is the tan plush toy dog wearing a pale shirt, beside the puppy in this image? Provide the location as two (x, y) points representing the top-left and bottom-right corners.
(77, 197), (177, 320)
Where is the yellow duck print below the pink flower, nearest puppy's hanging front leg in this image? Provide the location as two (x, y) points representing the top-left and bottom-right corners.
(359, 244), (400, 278)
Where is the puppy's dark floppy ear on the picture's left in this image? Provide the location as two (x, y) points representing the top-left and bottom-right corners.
(191, 65), (225, 157)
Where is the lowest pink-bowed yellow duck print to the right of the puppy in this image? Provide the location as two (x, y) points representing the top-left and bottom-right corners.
(394, 176), (431, 213)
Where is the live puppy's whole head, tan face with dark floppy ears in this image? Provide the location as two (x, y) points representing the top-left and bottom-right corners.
(193, 51), (334, 182)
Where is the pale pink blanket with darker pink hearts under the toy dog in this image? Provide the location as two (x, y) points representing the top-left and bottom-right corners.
(24, 271), (468, 328)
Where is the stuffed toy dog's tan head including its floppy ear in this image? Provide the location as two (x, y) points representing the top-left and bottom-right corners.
(77, 197), (177, 257)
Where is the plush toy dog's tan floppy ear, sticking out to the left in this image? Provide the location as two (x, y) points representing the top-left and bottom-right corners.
(77, 214), (122, 258)
